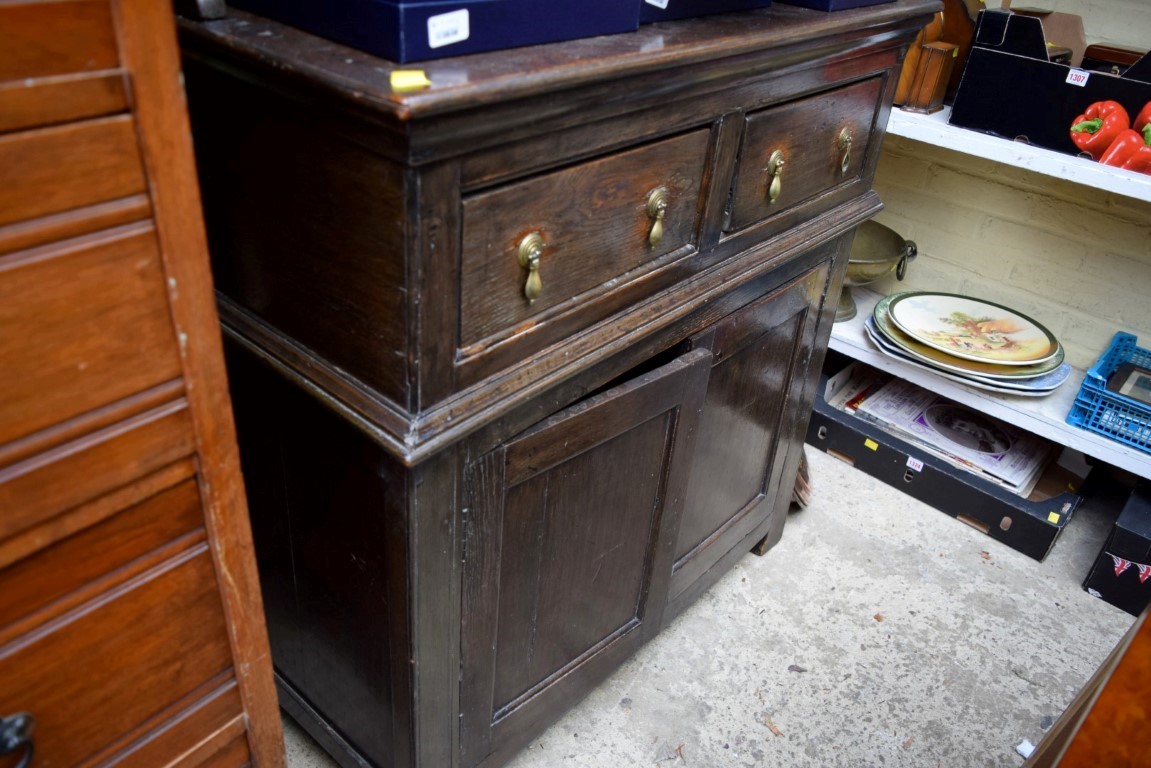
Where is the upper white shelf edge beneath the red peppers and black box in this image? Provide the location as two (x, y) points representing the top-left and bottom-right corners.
(887, 107), (1151, 201)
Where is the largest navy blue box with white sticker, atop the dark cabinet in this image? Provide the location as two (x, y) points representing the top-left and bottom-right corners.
(229, 0), (640, 63)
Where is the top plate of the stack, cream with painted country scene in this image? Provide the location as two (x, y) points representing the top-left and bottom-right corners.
(887, 291), (1060, 365)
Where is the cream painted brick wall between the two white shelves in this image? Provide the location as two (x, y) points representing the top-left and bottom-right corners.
(872, 136), (1151, 367)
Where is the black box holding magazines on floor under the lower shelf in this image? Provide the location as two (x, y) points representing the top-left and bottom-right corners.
(807, 366), (1082, 561)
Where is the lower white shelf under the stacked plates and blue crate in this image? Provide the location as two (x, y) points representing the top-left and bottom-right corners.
(831, 288), (1151, 479)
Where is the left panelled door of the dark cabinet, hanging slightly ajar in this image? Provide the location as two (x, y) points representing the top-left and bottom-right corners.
(460, 349), (711, 765)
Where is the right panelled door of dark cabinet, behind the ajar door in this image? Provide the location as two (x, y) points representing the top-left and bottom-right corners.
(668, 266), (828, 618)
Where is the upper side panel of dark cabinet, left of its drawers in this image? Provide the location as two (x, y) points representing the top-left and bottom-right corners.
(186, 61), (407, 405)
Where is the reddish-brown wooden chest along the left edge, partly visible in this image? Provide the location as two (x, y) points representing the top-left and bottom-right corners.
(0, 0), (283, 768)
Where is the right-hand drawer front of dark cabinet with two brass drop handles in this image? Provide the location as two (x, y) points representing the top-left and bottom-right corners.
(729, 77), (883, 230)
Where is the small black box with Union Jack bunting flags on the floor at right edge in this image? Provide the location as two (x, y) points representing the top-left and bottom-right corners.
(1083, 482), (1151, 616)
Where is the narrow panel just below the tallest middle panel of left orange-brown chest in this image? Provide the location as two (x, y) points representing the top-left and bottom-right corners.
(0, 401), (195, 538)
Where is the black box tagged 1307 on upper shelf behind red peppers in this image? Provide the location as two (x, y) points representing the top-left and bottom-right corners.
(951, 10), (1151, 154)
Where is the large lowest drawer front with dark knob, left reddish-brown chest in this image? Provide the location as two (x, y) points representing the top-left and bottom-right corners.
(0, 543), (230, 766)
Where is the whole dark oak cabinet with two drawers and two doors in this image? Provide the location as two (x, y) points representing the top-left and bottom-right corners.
(182, 0), (935, 768)
